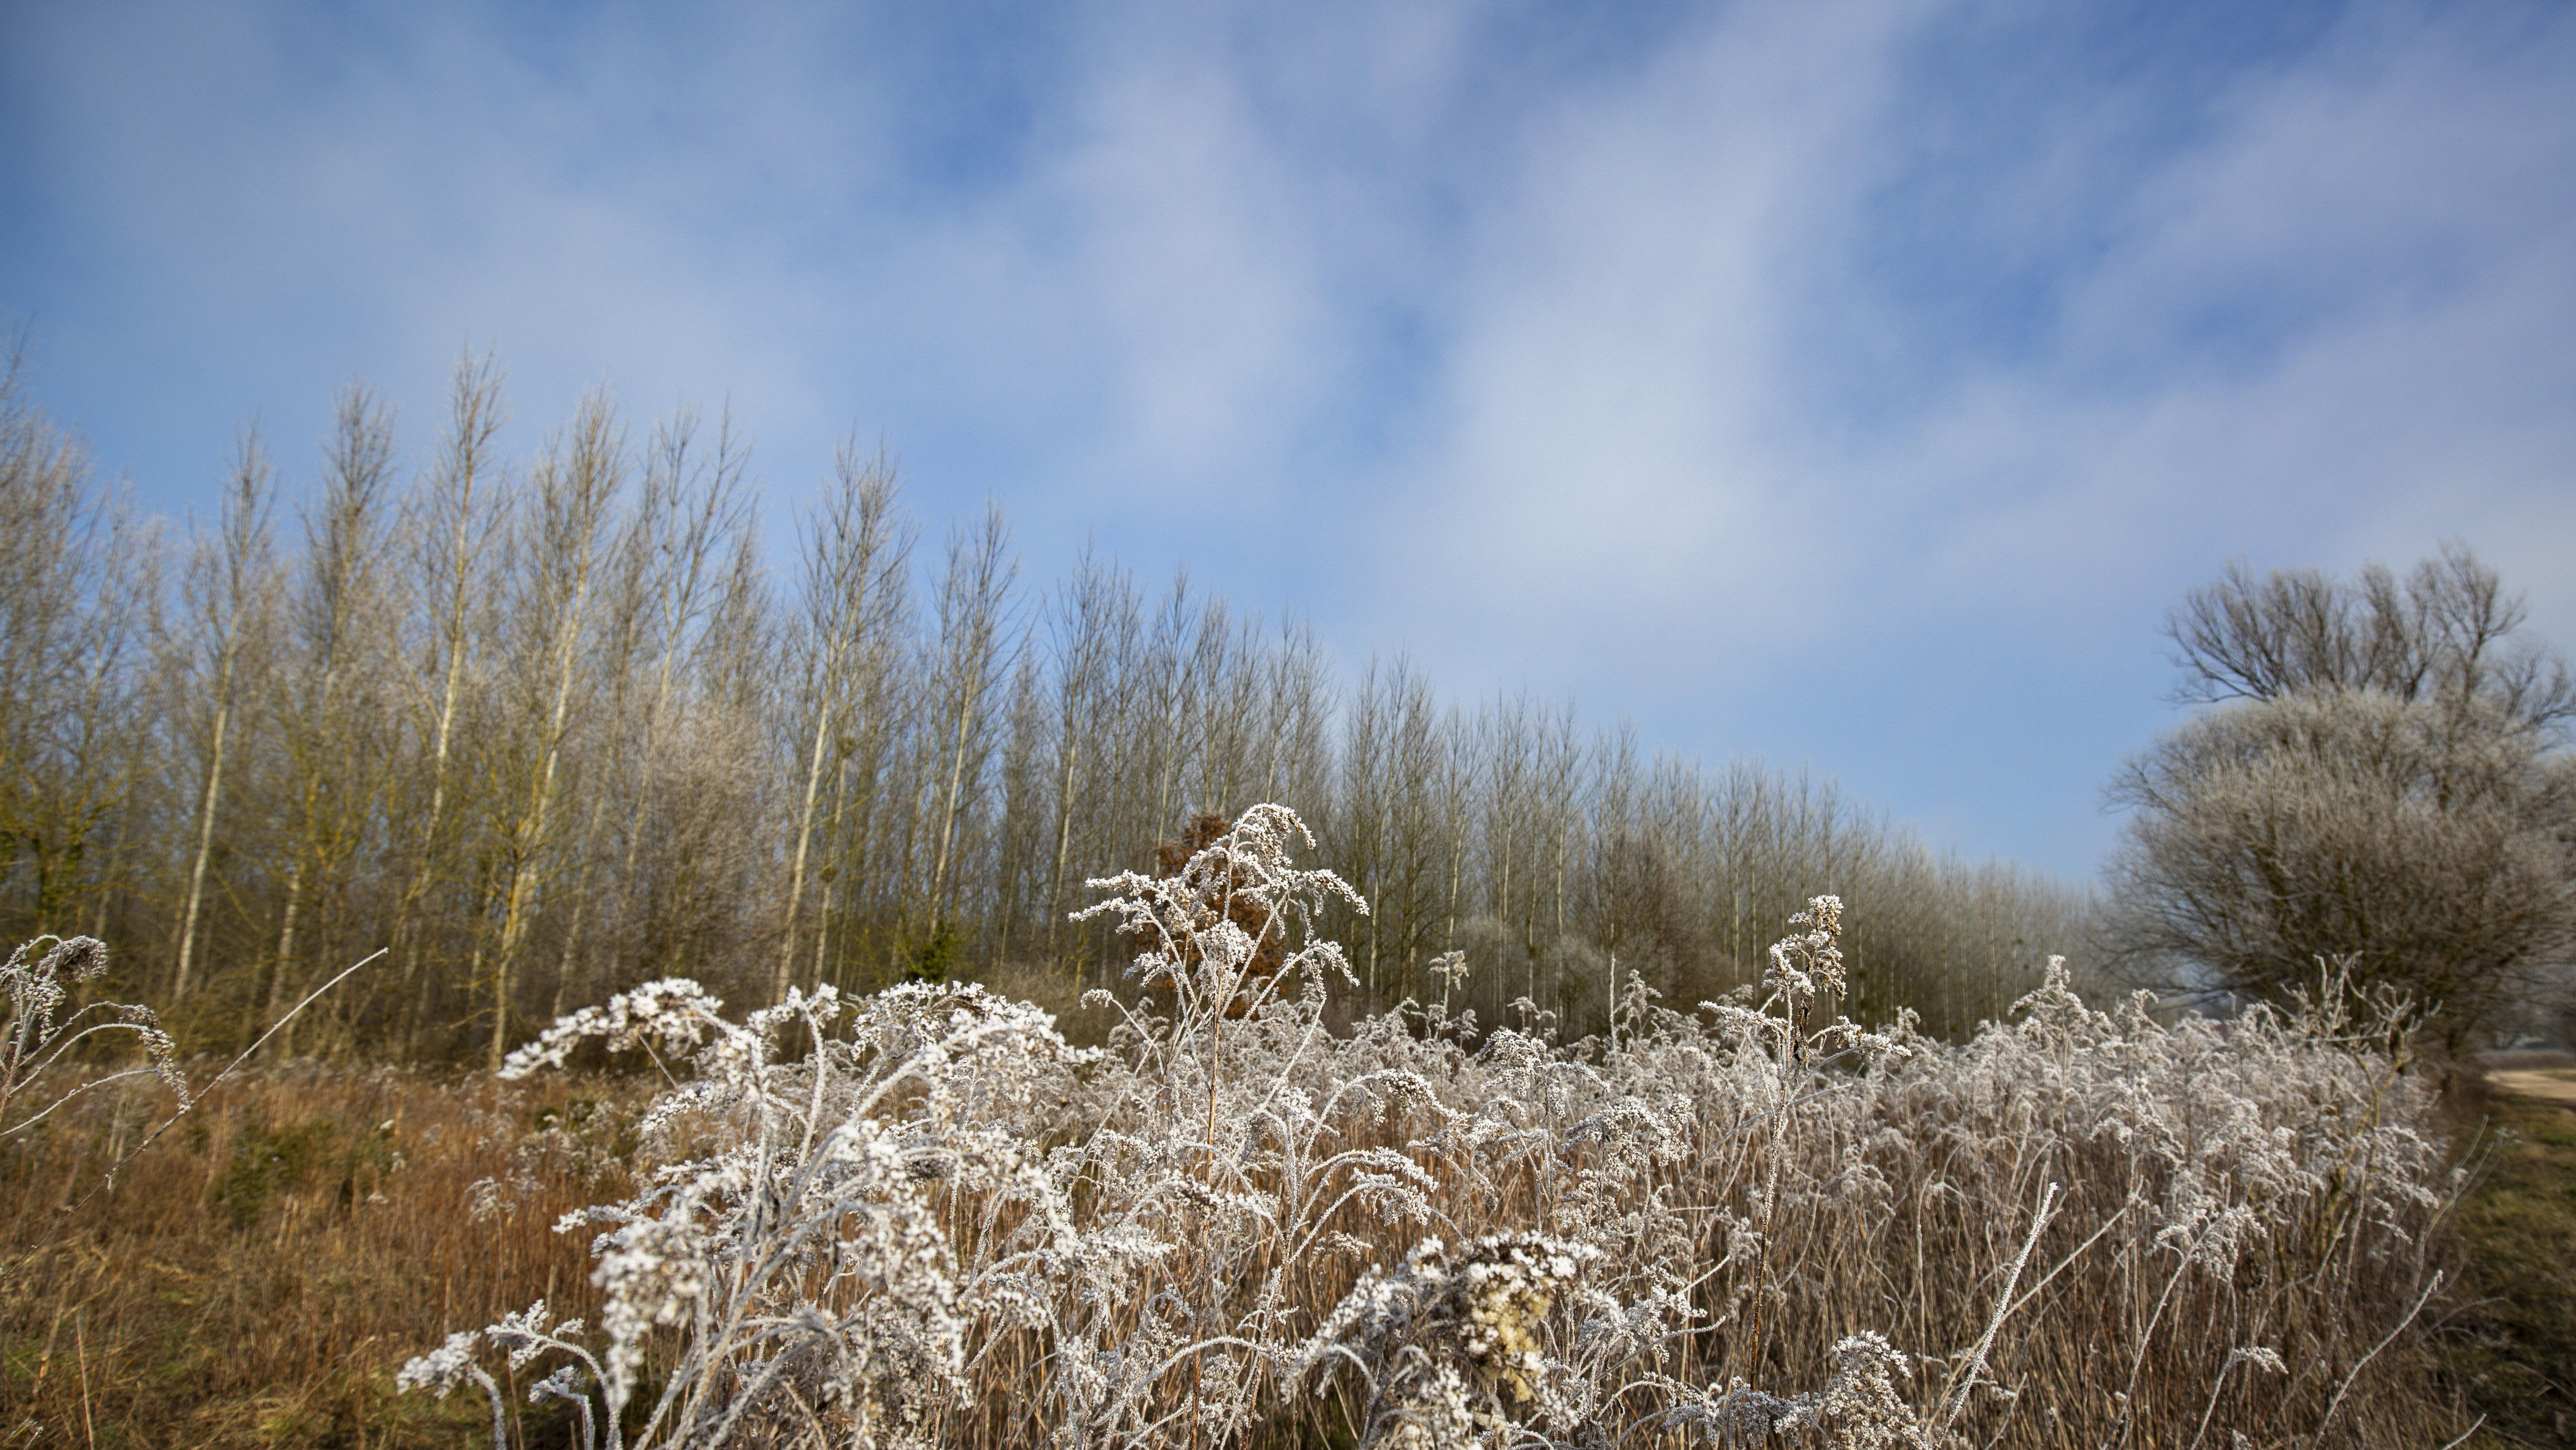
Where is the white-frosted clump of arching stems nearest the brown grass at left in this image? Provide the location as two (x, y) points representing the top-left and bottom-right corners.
(412, 979), (1082, 1445)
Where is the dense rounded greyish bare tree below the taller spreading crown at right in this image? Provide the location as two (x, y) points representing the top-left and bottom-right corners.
(2112, 688), (2576, 1046)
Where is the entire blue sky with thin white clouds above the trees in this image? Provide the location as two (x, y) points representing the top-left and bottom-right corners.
(0, 0), (2576, 876)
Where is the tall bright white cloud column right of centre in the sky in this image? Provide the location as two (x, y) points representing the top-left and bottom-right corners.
(1384, 7), (1917, 654)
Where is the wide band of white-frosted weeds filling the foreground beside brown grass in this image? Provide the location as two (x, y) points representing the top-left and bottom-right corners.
(405, 806), (2452, 1448)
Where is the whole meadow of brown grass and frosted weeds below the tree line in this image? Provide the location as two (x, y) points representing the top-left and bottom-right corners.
(0, 806), (2476, 1448)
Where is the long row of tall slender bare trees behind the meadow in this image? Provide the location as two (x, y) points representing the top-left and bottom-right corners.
(0, 345), (2089, 1061)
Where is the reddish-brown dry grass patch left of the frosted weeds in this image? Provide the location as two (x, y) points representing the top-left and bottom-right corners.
(0, 1069), (641, 1448)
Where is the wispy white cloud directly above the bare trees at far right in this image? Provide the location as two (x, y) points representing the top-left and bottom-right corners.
(1896, 3), (2576, 623)
